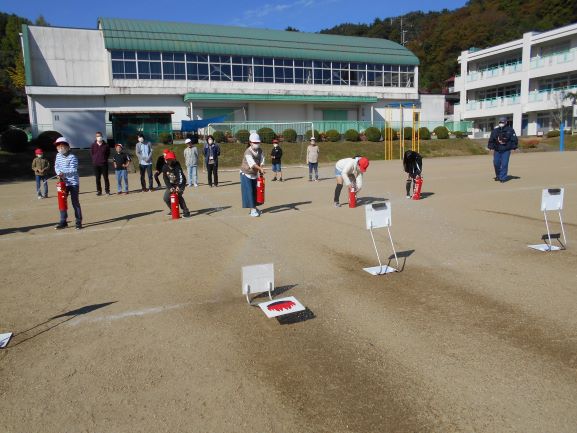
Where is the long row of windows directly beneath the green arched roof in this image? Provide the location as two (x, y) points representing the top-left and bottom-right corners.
(111, 51), (415, 87)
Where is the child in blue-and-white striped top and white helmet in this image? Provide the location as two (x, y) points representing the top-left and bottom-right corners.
(54, 137), (82, 230)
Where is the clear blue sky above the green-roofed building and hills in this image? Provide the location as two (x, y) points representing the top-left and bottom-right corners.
(0, 0), (466, 32)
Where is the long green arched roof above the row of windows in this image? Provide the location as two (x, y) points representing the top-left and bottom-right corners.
(98, 18), (419, 65)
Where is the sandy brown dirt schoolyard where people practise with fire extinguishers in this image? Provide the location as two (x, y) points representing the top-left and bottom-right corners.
(0, 152), (577, 433)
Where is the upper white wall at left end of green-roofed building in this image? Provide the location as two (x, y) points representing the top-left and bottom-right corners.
(28, 26), (110, 86)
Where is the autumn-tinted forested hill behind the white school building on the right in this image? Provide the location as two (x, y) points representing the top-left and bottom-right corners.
(321, 0), (577, 91)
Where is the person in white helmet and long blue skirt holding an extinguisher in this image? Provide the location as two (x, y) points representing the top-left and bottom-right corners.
(240, 132), (264, 217)
